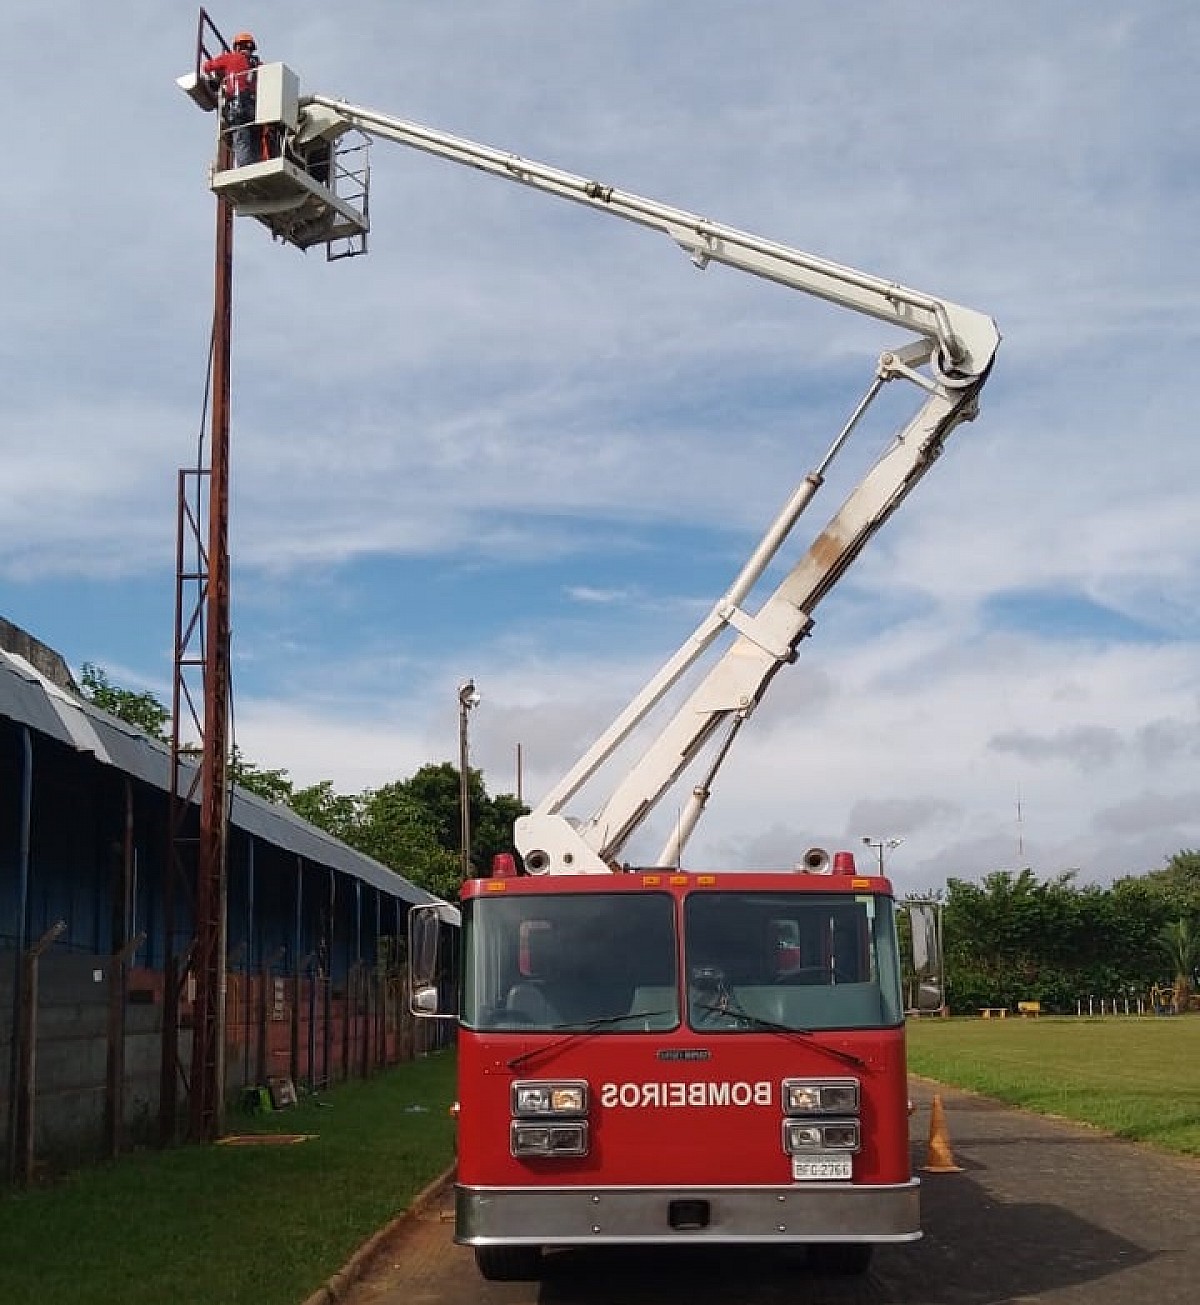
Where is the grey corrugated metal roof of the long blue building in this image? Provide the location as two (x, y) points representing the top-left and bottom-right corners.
(0, 649), (458, 923)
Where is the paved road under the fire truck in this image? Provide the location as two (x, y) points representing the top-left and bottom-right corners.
(336, 1083), (1200, 1305)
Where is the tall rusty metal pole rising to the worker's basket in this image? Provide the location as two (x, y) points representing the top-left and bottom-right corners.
(189, 138), (233, 1142)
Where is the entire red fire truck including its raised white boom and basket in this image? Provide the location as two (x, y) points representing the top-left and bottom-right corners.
(180, 35), (999, 1279)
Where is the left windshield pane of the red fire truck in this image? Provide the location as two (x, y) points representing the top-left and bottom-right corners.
(462, 893), (680, 1034)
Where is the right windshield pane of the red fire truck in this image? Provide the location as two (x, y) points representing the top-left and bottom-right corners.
(683, 893), (904, 1032)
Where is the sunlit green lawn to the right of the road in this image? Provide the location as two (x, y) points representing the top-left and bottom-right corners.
(908, 1015), (1200, 1155)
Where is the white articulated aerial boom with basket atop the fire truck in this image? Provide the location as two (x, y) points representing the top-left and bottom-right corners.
(180, 58), (1000, 874)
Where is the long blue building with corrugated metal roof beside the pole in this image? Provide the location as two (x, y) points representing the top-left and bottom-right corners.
(0, 621), (458, 1167)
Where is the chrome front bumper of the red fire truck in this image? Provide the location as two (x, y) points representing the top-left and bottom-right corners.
(454, 1178), (921, 1246)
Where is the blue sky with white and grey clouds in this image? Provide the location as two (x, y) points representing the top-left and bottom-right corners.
(0, 0), (1200, 889)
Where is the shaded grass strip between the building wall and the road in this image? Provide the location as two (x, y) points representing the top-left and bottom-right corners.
(0, 1052), (455, 1305)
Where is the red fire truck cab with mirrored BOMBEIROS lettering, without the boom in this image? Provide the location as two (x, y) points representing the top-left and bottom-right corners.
(422, 867), (921, 1279)
